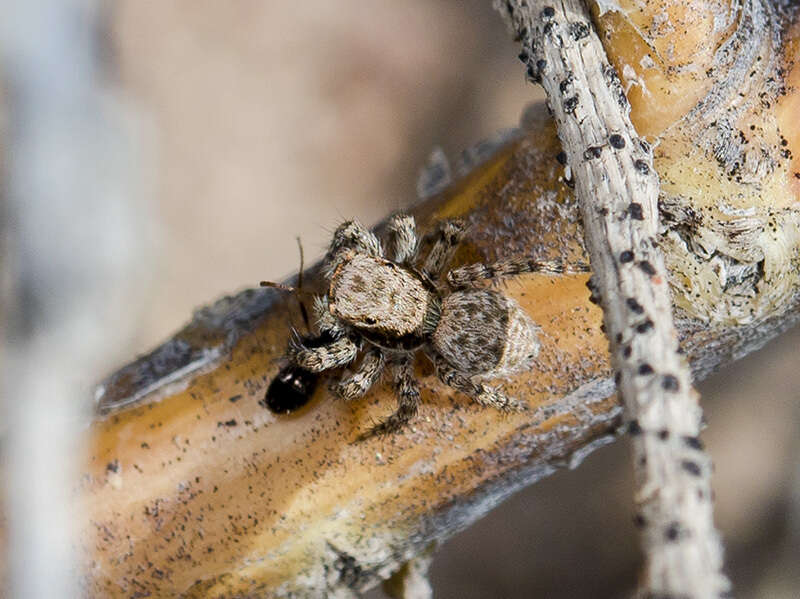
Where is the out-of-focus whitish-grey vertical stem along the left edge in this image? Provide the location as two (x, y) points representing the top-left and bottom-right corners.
(0, 0), (147, 597)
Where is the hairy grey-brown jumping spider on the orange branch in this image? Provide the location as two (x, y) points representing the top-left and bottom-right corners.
(287, 215), (588, 439)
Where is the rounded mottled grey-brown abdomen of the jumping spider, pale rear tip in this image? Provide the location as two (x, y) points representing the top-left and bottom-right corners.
(431, 289), (540, 376)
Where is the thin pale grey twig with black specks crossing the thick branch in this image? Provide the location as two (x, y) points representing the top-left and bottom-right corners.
(495, 0), (730, 597)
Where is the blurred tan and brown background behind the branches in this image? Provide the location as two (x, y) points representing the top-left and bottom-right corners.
(3, 0), (800, 599)
